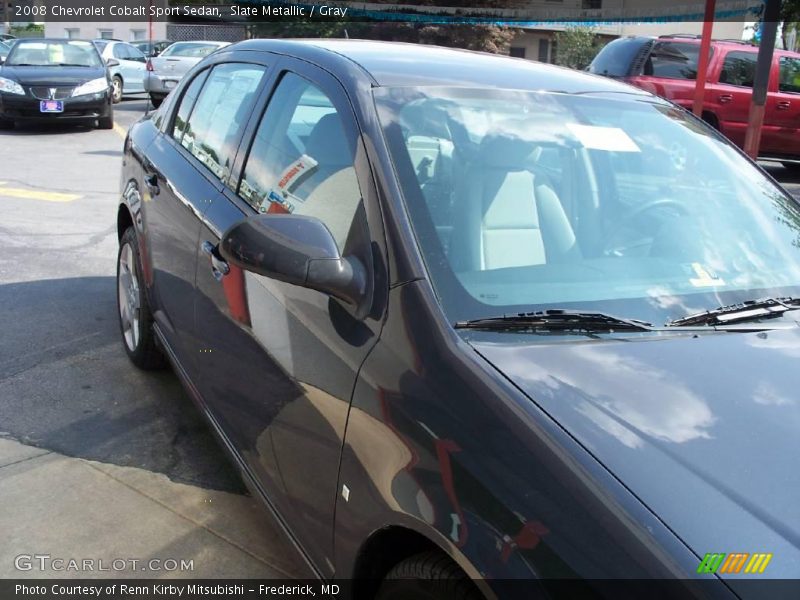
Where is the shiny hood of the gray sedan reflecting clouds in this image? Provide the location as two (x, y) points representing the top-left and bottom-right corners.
(465, 327), (800, 578)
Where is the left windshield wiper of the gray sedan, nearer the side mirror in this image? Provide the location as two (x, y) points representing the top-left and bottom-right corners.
(455, 309), (653, 332)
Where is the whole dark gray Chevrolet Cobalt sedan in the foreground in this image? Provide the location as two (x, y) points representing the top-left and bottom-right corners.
(117, 40), (800, 598)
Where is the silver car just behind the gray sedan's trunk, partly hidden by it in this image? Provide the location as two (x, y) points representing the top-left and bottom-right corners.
(144, 41), (230, 107)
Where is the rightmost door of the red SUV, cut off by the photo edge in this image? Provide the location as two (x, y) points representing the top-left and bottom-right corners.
(761, 55), (800, 157)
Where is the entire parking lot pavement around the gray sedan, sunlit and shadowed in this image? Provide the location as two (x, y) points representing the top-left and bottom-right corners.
(0, 100), (800, 578)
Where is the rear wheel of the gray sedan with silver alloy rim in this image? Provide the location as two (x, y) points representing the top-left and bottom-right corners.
(117, 227), (167, 371)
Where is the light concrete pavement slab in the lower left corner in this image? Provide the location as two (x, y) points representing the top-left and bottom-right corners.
(0, 438), (307, 579)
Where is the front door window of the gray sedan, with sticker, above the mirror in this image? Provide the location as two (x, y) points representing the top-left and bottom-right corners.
(239, 73), (361, 250)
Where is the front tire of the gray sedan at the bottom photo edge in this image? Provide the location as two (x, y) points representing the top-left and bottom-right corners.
(376, 552), (483, 600)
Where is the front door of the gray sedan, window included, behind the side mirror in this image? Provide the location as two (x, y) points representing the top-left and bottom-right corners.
(191, 58), (385, 576)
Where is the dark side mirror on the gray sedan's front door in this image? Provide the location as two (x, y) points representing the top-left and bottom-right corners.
(219, 214), (369, 314)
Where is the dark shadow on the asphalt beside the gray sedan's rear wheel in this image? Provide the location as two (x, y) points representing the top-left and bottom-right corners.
(0, 277), (246, 494)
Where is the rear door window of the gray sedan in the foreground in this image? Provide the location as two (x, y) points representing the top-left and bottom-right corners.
(180, 63), (266, 180)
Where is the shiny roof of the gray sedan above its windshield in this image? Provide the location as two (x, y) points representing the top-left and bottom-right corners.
(225, 39), (650, 96)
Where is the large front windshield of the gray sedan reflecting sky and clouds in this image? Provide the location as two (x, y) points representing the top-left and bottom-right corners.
(374, 88), (800, 323)
